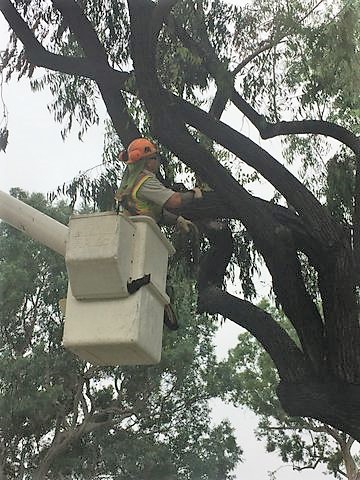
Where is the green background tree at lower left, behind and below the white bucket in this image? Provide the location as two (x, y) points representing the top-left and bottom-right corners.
(0, 189), (241, 480)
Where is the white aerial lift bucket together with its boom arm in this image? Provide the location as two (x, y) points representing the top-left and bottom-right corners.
(0, 191), (174, 365)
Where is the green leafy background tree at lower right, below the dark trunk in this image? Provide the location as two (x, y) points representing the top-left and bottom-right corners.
(218, 300), (360, 480)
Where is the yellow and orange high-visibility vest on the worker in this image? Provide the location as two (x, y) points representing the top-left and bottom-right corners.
(120, 172), (162, 222)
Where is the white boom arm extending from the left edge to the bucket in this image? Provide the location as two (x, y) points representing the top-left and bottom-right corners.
(0, 191), (69, 256)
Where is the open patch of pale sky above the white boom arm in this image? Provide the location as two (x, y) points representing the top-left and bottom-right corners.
(0, 79), (103, 193)
